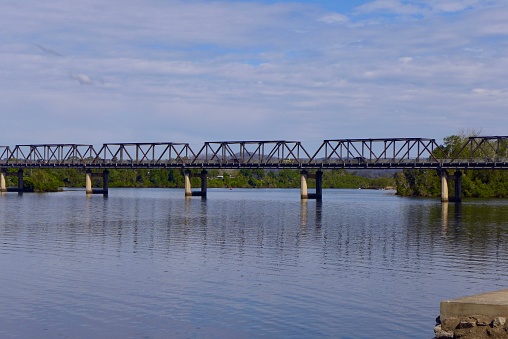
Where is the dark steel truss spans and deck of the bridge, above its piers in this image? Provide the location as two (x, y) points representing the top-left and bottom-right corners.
(0, 136), (508, 170)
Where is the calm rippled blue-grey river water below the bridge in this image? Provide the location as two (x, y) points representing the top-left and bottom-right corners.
(0, 189), (508, 338)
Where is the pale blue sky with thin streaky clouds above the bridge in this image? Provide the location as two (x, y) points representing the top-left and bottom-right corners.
(0, 0), (508, 145)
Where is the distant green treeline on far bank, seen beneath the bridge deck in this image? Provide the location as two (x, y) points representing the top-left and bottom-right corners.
(1, 168), (395, 192)
